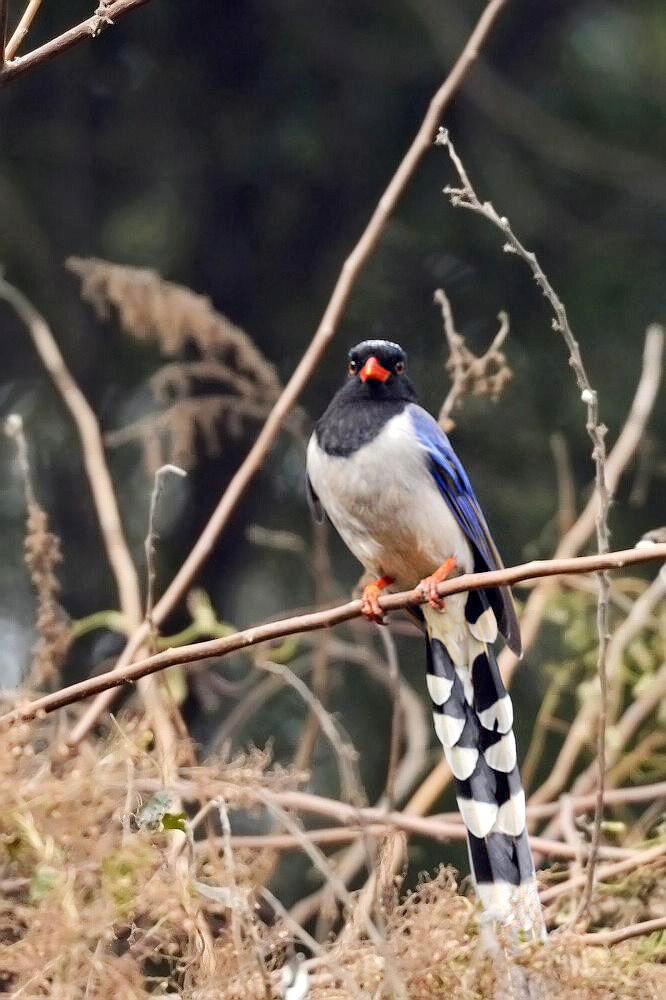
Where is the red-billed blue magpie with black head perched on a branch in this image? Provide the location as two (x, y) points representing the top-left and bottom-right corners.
(307, 340), (543, 937)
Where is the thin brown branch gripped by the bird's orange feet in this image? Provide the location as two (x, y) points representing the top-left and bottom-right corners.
(0, 543), (666, 724)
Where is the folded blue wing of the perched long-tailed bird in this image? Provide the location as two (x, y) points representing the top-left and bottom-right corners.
(409, 404), (520, 655)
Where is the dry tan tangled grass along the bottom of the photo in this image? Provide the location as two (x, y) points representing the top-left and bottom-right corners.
(0, 718), (666, 1000)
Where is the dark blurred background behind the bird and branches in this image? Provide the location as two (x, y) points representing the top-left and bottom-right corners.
(0, 0), (666, 900)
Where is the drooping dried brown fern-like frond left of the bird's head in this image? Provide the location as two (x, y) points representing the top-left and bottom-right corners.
(67, 257), (290, 474)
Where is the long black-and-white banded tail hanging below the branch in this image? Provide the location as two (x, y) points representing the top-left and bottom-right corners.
(423, 594), (545, 938)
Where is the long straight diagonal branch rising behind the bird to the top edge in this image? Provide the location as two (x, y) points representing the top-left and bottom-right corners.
(63, 0), (506, 745)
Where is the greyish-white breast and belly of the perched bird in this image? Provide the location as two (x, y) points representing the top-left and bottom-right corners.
(307, 410), (472, 590)
